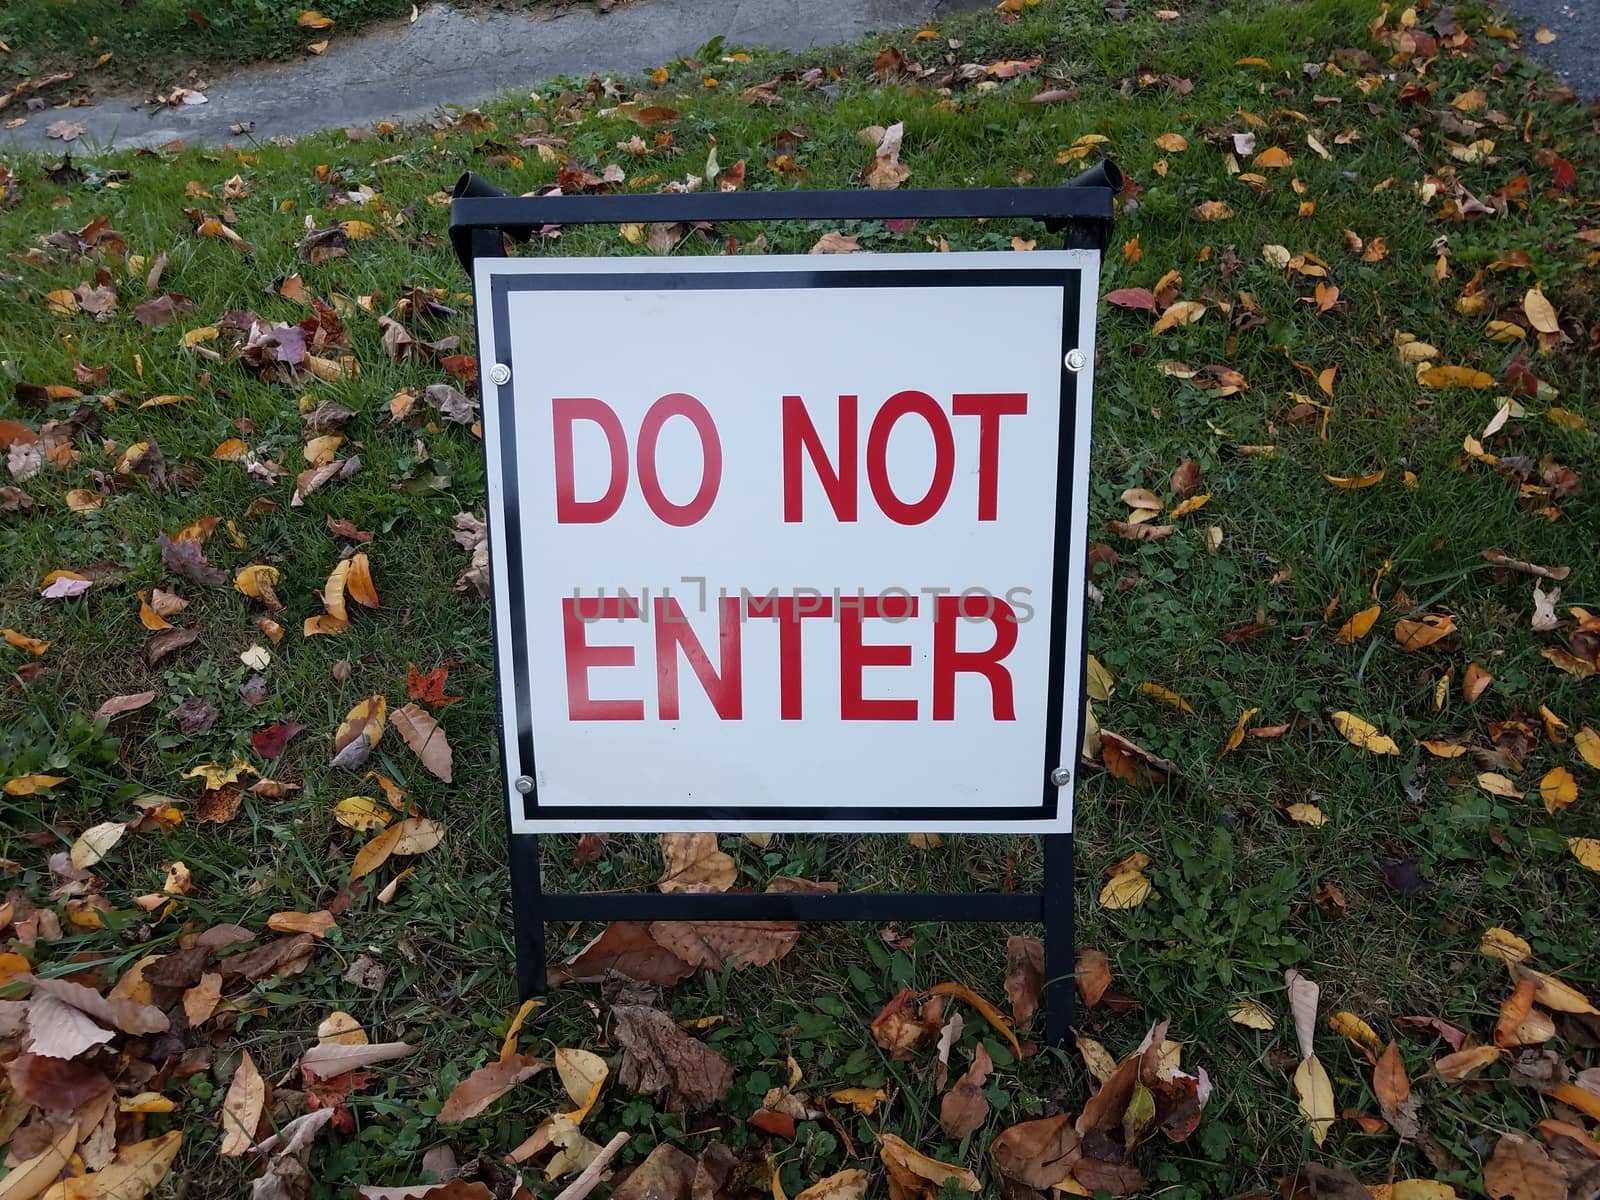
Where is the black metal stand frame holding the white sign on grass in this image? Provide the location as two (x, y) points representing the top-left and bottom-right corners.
(450, 173), (1122, 1045)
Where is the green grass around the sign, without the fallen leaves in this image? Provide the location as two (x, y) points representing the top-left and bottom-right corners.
(0, 0), (1600, 1197)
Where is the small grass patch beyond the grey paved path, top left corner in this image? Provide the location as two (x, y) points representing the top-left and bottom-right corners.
(0, 0), (569, 101)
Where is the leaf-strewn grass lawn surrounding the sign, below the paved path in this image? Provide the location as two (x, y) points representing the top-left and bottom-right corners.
(0, 0), (1600, 1200)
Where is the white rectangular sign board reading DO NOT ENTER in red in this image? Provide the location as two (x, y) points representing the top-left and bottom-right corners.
(475, 251), (1099, 832)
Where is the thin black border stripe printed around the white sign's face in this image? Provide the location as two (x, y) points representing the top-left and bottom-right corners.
(485, 266), (1085, 832)
